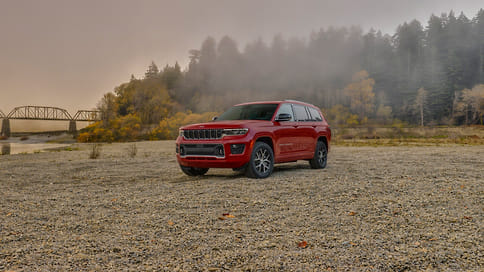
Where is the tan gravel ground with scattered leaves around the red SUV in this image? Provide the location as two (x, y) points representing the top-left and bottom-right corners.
(0, 141), (484, 271)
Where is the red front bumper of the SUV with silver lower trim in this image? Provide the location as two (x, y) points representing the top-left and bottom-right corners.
(176, 136), (253, 168)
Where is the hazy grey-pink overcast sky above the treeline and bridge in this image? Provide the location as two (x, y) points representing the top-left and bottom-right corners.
(0, 0), (484, 113)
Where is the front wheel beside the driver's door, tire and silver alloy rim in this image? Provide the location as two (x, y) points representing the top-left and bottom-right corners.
(245, 142), (274, 178)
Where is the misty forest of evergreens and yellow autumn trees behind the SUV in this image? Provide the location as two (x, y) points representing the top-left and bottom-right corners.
(79, 9), (484, 141)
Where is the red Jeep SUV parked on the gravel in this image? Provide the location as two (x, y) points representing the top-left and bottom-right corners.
(176, 100), (331, 178)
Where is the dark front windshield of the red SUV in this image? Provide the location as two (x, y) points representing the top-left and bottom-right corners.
(217, 104), (278, 121)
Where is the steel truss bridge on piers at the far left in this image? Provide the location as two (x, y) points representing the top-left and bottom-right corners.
(0, 106), (102, 137)
